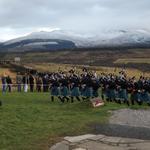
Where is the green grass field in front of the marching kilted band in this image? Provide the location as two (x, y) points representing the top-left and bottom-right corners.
(0, 92), (148, 150)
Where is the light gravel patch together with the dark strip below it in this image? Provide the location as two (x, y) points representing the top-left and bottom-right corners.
(93, 109), (150, 140)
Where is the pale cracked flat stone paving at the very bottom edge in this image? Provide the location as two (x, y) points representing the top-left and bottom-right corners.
(50, 134), (150, 150)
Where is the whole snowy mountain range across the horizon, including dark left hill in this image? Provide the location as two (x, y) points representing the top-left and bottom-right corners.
(0, 30), (150, 51)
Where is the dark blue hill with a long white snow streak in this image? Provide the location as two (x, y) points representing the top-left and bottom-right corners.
(0, 39), (76, 52)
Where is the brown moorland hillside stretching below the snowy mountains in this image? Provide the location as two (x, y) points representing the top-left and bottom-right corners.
(0, 49), (150, 72)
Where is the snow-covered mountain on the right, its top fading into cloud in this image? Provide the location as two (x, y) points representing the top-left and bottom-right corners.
(90, 30), (150, 47)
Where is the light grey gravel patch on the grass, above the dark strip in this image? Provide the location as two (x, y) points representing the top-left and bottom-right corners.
(109, 109), (150, 128)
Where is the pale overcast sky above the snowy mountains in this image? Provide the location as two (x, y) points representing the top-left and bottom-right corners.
(0, 0), (150, 40)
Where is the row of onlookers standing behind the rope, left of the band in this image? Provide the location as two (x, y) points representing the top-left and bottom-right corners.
(1, 72), (50, 93)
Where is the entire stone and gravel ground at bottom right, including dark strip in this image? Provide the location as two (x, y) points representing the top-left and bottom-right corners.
(50, 109), (150, 150)
